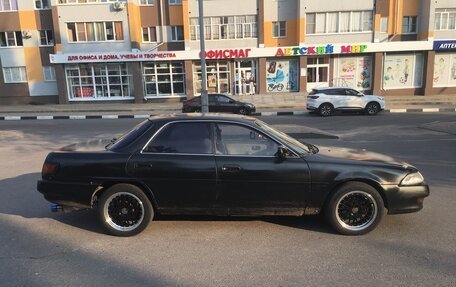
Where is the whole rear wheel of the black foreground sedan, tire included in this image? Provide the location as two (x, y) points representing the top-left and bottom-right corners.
(98, 183), (154, 237)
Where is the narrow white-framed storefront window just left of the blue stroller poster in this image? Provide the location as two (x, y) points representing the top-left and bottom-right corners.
(233, 61), (257, 95)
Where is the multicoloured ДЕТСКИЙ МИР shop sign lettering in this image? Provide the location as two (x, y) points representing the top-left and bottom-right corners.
(275, 44), (367, 57)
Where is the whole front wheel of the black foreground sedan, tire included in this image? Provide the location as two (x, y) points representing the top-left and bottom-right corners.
(325, 182), (384, 235)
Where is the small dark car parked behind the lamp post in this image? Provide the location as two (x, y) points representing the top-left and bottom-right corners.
(182, 94), (255, 115)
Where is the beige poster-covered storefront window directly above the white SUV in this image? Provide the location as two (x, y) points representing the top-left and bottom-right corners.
(332, 56), (372, 90)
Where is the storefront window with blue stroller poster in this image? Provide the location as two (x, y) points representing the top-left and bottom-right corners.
(266, 60), (298, 92)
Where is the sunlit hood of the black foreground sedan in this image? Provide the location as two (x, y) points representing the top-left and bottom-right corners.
(319, 146), (416, 169)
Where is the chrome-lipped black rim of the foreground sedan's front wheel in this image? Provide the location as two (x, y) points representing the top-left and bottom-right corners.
(336, 191), (378, 231)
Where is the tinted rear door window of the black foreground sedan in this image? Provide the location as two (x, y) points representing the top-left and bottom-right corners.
(144, 123), (212, 154)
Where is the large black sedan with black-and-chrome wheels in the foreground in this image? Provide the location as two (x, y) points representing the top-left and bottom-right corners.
(38, 114), (429, 236)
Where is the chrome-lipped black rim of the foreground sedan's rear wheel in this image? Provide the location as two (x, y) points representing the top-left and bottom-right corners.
(103, 192), (144, 232)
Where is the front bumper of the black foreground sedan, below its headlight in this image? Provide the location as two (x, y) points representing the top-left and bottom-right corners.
(382, 184), (429, 214)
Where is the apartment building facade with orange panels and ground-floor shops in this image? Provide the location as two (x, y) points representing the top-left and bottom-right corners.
(0, 0), (456, 105)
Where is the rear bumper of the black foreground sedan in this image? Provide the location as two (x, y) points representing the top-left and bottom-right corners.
(37, 180), (98, 208)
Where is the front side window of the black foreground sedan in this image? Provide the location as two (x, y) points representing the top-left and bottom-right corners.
(214, 124), (279, 156)
